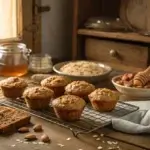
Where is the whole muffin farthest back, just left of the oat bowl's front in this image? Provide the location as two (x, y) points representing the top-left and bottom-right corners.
(41, 76), (70, 98)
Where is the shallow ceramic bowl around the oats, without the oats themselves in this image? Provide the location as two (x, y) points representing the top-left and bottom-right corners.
(53, 61), (112, 83)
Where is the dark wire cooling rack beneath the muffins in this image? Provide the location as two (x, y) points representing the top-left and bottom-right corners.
(0, 99), (139, 137)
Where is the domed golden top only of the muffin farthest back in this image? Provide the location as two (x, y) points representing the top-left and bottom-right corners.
(41, 76), (69, 88)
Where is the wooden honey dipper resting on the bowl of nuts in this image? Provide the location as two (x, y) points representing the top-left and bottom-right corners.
(133, 66), (150, 87)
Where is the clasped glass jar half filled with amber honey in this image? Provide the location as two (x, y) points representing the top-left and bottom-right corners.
(0, 43), (31, 76)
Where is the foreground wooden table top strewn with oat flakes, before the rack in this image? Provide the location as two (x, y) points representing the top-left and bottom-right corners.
(0, 74), (150, 150)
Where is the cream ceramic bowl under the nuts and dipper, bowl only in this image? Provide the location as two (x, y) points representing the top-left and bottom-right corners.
(112, 75), (150, 99)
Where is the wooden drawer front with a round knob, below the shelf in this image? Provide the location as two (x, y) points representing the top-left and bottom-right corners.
(85, 38), (148, 71)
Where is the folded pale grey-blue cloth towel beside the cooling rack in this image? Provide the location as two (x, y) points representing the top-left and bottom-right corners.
(112, 110), (150, 134)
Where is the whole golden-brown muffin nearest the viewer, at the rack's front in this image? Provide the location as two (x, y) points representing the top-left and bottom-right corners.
(52, 95), (86, 121)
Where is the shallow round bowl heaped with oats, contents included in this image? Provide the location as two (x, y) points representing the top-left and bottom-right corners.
(53, 60), (112, 83)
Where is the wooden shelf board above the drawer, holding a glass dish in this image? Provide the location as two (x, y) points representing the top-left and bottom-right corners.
(77, 29), (150, 43)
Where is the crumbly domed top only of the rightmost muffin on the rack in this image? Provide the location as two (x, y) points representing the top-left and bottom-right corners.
(88, 88), (119, 101)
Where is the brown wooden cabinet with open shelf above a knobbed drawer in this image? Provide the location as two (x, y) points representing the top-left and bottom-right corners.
(72, 0), (150, 71)
